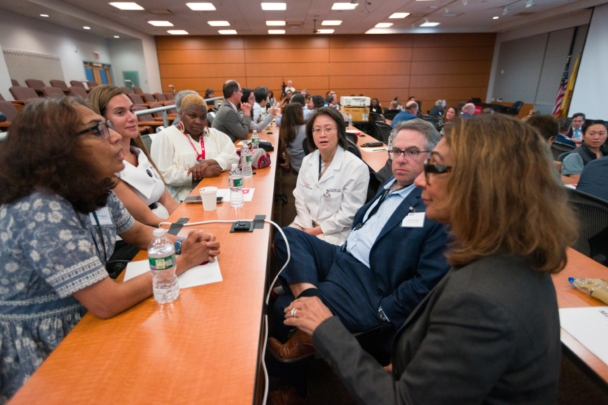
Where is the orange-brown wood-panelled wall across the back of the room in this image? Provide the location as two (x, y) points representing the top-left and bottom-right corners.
(156, 34), (495, 111)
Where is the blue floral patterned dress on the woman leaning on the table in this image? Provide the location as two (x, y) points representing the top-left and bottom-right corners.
(0, 192), (135, 403)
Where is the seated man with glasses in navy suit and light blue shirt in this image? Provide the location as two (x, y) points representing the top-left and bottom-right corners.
(269, 119), (449, 359)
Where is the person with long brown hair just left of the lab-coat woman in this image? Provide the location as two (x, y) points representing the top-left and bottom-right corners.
(279, 103), (306, 173)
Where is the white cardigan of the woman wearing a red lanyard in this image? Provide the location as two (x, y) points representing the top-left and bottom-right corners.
(151, 125), (239, 201)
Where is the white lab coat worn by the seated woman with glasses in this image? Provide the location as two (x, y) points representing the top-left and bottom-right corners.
(292, 146), (369, 245)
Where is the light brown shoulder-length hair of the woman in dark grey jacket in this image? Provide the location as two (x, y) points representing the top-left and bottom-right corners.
(444, 114), (577, 273)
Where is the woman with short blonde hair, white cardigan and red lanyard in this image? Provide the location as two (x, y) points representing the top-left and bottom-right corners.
(152, 94), (239, 201)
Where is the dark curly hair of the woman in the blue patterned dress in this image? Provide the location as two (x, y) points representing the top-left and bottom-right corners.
(0, 97), (115, 214)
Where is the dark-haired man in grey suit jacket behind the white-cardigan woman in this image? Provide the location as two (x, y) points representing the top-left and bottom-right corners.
(212, 80), (252, 142)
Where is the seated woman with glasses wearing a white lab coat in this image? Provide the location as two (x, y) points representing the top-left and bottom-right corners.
(291, 108), (369, 245)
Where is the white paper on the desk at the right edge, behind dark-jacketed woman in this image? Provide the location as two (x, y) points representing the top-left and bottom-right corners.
(559, 307), (608, 364)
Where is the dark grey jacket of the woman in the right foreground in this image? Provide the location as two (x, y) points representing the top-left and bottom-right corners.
(313, 255), (561, 405)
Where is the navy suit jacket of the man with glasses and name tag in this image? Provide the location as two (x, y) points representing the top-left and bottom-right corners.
(353, 176), (450, 328)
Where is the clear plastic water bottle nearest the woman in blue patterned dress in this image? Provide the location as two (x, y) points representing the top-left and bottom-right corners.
(148, 229), (179, 304)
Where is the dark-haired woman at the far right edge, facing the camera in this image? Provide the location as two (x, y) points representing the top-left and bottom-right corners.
(562, 120), (608, 180)
